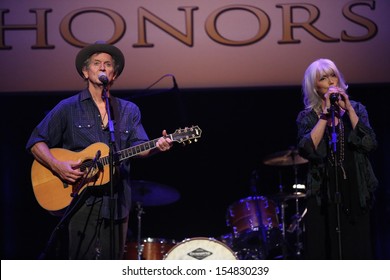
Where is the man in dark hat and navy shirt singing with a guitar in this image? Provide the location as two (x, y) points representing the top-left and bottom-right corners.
(26, 42), (172, 259)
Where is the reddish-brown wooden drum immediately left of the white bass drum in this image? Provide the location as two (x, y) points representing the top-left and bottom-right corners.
(124, 237), (176, 260)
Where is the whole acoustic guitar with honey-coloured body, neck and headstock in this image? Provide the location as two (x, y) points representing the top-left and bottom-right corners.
(31, 126), (202, 212)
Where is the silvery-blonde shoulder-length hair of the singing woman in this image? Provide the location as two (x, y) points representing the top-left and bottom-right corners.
(302, 58), (348, 113)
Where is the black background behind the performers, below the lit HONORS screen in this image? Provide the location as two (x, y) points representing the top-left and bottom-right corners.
(0, 84), (390, 259)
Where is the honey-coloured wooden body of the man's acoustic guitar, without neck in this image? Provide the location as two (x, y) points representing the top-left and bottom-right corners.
(31, 142), (110, 211)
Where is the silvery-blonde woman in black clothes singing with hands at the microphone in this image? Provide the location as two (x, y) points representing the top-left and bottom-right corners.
(296, 58), (378, 259)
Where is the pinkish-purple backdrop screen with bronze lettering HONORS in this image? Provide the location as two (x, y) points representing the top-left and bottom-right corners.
(0, 0), (390, 93)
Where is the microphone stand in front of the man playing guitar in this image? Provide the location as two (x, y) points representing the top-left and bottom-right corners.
(102, 83), (115, 260)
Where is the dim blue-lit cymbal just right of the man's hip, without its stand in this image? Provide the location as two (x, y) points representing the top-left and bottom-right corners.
(131, 180), (180, 206)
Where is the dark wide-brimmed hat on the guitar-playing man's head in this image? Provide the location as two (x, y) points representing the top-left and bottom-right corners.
(76, 41), (125, 79)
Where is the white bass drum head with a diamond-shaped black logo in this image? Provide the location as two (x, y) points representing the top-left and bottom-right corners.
(164, 237), (238, 260)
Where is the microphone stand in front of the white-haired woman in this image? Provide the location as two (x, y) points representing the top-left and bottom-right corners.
(330, 102), (342, 260)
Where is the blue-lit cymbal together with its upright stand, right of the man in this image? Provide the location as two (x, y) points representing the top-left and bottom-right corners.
(131, 180), (180, 260)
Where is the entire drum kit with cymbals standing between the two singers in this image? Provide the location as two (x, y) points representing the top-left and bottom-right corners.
(124, 148), (307, 260)
